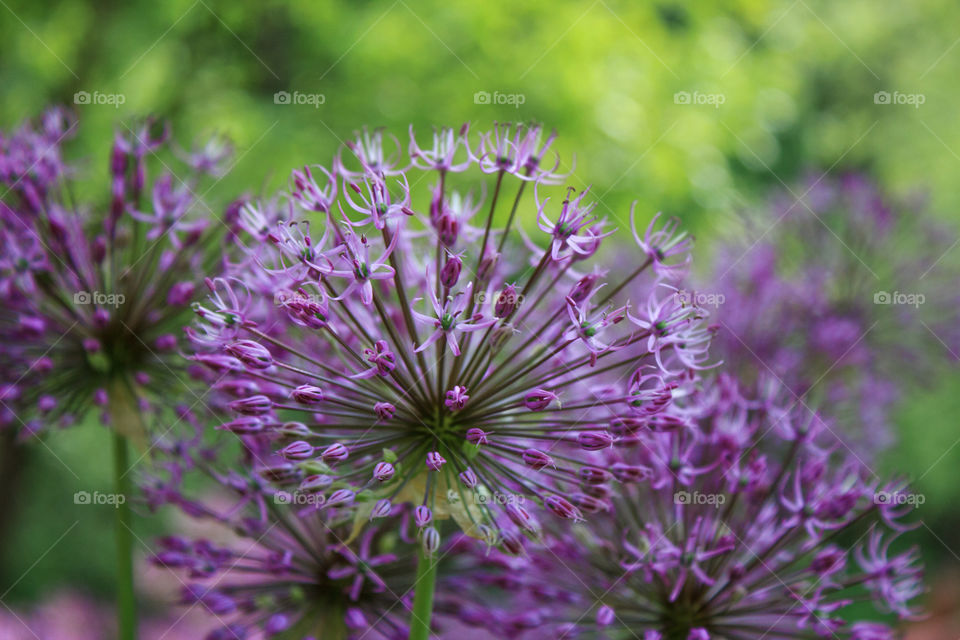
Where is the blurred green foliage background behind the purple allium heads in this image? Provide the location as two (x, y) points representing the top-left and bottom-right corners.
(0, 0), (960, 638)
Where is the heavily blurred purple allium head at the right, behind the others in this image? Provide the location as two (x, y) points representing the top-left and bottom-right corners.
(700, 174), (960, 458)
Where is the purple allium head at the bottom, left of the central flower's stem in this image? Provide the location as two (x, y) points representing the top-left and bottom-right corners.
(142, 423), (464, 640)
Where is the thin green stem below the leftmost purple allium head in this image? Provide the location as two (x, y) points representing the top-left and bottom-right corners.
(113, 431), (137, 640)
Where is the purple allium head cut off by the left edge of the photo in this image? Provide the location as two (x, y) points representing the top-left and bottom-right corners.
(0, 109), (228, 441)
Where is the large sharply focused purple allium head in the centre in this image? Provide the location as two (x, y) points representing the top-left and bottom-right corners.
(192, 125), (711, 550)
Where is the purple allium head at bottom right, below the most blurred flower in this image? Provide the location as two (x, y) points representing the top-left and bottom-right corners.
(452, 375), (923, 640)
